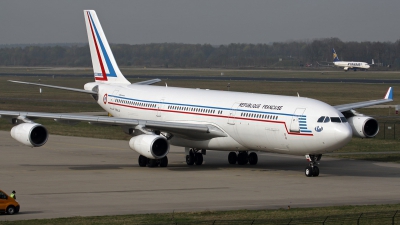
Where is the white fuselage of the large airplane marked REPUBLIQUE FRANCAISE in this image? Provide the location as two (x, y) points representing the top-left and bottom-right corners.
(85, 83), (352, 155)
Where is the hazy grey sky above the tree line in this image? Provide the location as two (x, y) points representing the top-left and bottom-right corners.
(0, 0), (400, 45)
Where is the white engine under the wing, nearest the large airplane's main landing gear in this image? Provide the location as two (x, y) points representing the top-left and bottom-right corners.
(129, 134), (169, 159)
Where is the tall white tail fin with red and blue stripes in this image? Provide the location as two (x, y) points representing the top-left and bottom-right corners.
(83, 10), (130, 84)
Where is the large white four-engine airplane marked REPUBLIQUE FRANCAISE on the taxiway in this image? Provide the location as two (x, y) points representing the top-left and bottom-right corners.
(0, 10), (393, 177)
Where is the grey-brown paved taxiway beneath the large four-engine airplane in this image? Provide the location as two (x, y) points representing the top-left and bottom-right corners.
(0, 131), (400, 221)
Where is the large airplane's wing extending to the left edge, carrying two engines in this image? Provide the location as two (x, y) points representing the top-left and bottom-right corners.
(0, 110), (227, 140)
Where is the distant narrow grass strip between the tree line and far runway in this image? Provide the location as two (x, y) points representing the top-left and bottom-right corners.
(0, 67), (400, 79)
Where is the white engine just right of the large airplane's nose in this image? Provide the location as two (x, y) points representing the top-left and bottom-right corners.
(347, 116), (379, 138)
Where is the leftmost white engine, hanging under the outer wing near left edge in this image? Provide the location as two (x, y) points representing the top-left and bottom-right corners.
(11, 123), (49, 147)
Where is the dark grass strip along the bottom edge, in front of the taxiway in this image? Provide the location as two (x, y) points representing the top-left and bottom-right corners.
(0, 204), (400, 225)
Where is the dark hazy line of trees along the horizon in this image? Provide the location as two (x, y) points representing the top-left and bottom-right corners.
(0, 38), (400, 69)
